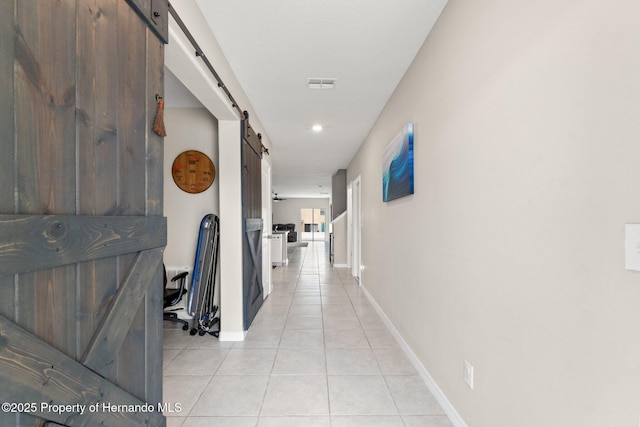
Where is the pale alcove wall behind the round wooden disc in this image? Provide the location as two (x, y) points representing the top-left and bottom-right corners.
(164, 108), (220, 268)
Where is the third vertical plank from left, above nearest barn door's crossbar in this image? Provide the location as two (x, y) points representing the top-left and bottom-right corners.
(76, 0), (119, 215)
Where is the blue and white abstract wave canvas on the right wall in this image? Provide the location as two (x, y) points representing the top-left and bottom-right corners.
(382, 123), (413, 202)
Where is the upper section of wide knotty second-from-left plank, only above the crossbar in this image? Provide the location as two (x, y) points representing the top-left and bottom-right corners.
(14, 0), (76, 214)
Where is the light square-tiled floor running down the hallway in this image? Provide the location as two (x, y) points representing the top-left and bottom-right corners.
(163, 242), (452, 427)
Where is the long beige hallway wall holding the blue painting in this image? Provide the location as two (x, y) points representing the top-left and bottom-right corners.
(348, 0), (640, 427)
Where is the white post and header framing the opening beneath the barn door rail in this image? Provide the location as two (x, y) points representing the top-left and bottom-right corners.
(165, 0), (273, 341)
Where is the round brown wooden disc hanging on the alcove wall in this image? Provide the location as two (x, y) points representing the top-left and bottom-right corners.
(171, 150), (216, 194)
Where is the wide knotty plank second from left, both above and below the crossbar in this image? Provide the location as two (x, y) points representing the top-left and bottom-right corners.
(13, 0), (77, 372)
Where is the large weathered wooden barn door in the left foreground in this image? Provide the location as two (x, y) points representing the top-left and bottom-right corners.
(0, 0), (167, 426)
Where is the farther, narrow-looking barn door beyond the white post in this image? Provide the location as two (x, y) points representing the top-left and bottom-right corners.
(242, 120), (264, 330)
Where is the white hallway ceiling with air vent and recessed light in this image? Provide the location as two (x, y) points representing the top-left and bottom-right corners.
(165, 0), (446, 197)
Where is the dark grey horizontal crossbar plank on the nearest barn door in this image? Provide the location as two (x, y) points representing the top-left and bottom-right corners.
(0, 215), (167, 276)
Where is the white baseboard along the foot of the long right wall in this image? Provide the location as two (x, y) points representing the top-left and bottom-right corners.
(360, 286), (468, 427)
